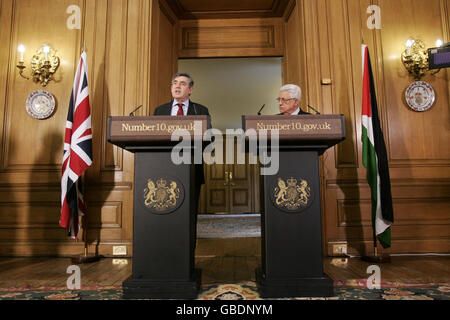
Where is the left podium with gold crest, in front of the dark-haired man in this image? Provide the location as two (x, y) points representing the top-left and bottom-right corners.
(108, 116), (210, 299)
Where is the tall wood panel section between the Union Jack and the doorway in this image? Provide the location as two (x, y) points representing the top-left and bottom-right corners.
(84, 1), (156, 255)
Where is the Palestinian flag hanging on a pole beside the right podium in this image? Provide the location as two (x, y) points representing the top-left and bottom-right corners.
(362, 45), (394, 248)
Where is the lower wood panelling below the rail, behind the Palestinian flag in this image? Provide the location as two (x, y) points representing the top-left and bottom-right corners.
(327, 181), (450, 254)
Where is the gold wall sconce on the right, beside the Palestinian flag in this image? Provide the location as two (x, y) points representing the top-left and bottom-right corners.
(402, 39), (443, 81)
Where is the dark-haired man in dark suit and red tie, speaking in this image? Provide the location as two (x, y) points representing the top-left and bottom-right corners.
(153, 73), (209, 250)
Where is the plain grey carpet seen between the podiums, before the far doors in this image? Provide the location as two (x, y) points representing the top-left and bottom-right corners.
(197, 214), (261, 239)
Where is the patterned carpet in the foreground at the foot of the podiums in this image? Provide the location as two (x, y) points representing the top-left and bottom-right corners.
(0, 280), (450, 300)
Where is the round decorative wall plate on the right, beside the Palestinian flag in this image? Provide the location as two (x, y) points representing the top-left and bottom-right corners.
(405, 81), (436, 112)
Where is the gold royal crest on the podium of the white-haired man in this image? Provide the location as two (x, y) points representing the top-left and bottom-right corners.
(271, 176), (314, 213)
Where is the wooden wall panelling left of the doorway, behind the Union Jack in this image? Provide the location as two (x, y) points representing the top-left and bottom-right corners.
(0, 0), (147, 255)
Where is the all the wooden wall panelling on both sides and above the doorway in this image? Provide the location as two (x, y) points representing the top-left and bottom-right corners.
(0, 0), (450, 255)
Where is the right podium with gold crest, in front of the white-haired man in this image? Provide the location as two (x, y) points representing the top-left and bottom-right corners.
(243, 115), (345, 298)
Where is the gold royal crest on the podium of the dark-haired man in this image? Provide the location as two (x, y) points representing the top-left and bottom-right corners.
(144, 177), (184, 214)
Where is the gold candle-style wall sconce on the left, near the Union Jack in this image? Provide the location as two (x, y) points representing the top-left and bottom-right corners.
(17, 44), (59, 87)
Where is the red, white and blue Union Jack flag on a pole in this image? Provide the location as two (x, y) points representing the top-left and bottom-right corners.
(59, 52), (92, 239)
